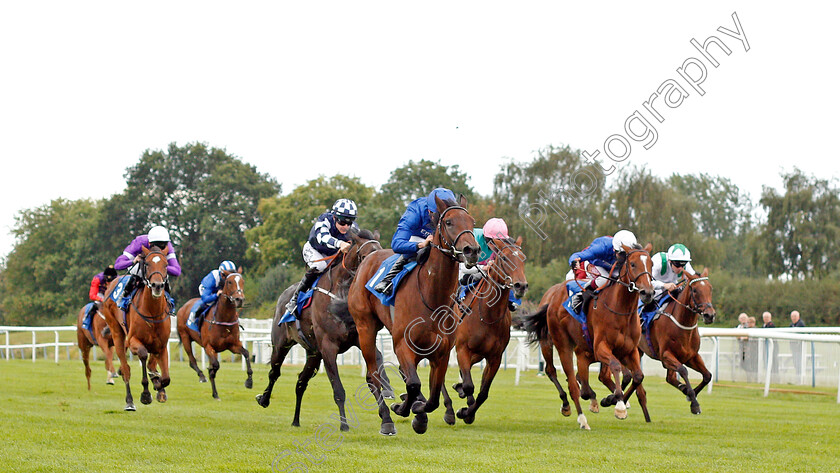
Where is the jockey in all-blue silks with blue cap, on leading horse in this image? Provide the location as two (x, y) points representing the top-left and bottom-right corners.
(373, 187), (457, 295)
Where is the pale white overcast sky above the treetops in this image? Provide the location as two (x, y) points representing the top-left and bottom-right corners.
(0, 0), (840, 255)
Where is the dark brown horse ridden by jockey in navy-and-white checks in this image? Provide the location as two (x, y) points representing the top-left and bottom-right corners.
(257, 230), (396, 431)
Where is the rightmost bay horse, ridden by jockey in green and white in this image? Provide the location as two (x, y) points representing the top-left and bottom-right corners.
(602, 268), (716, 414)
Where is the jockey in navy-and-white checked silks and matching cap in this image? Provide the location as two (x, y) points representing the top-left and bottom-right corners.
(286, 199), (359, 314)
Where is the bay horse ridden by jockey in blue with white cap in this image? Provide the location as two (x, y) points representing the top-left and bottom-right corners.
(525, 244), (653, 430)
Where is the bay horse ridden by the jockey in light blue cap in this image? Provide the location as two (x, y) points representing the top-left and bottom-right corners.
(176, 266), (249, 400)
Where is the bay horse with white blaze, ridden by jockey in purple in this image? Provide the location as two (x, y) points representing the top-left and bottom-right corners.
(100, 246), (171, 411)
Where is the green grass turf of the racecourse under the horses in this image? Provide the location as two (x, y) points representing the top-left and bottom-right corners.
(0, 360), (840, 472)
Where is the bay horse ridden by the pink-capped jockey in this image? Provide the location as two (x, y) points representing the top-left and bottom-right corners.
(443, 237), (528, 425)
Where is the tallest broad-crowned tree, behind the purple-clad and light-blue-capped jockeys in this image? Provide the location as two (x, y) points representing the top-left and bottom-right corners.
(115, 143), (280, 300)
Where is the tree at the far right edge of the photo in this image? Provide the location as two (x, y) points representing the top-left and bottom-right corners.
(759, 168), (840, 279)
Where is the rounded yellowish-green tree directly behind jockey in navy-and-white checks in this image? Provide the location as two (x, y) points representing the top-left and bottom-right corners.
(245, 174), (374, 275)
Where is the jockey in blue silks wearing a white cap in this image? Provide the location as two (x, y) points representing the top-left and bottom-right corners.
(569, 230), (638, 312)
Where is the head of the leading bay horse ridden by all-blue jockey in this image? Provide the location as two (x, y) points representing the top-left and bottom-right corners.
(433, 195), (481, 268)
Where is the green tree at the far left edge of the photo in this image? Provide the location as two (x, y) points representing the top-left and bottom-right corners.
(0, 199), (108, 325)
